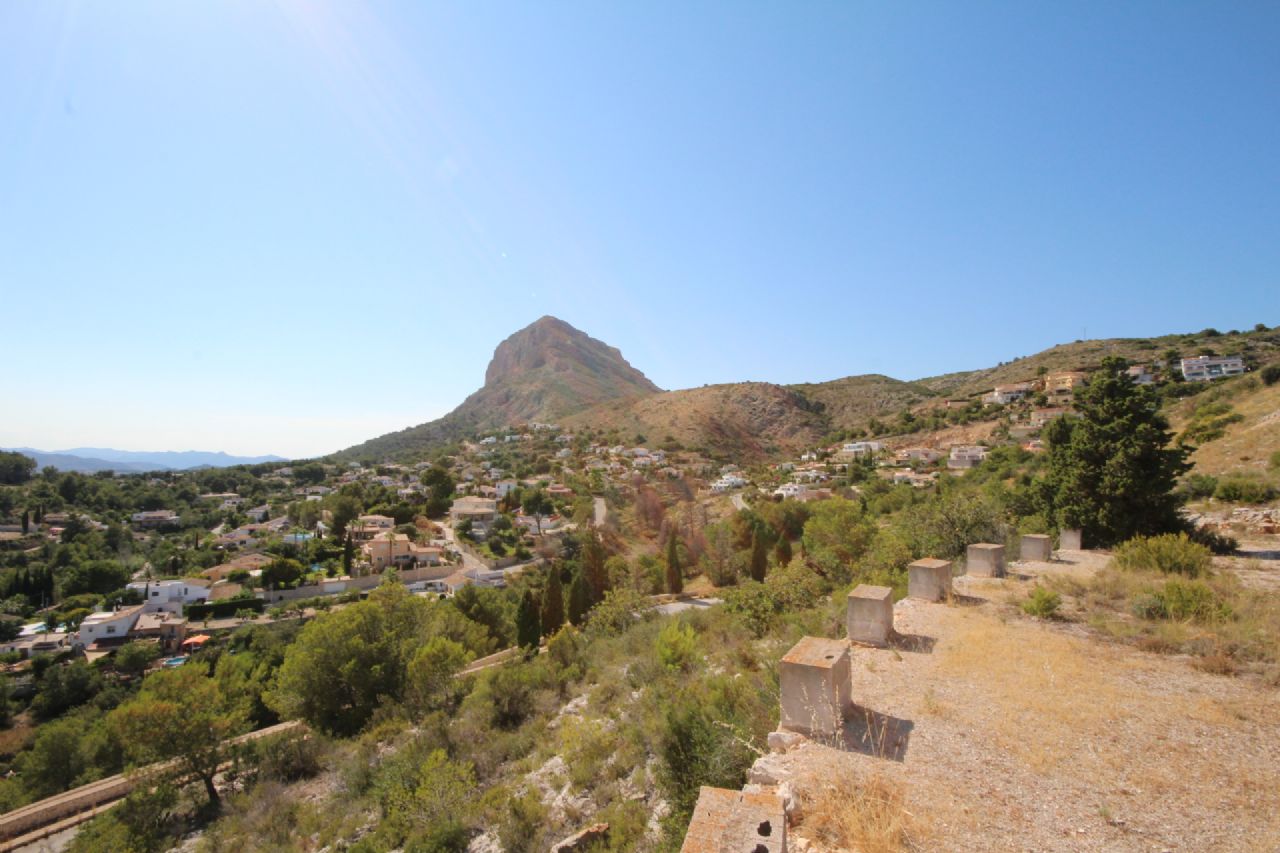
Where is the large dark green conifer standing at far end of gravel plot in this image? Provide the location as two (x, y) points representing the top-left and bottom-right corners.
(1041, 359), (1190, 547)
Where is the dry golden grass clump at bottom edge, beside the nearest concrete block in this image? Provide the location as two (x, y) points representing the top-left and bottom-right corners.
(796, 774), (923, 853)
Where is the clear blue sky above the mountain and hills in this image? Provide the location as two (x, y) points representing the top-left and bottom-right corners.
(0, 0), (1280, 456)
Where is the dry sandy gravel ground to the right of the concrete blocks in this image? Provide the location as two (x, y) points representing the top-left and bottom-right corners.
(764, 553), (1280, 850)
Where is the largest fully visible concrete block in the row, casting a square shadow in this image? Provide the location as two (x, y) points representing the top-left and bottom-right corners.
(778, 637), (854, 735)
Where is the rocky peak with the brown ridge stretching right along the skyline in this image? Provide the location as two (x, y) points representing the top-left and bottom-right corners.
(333, 316), (1280, 461)
